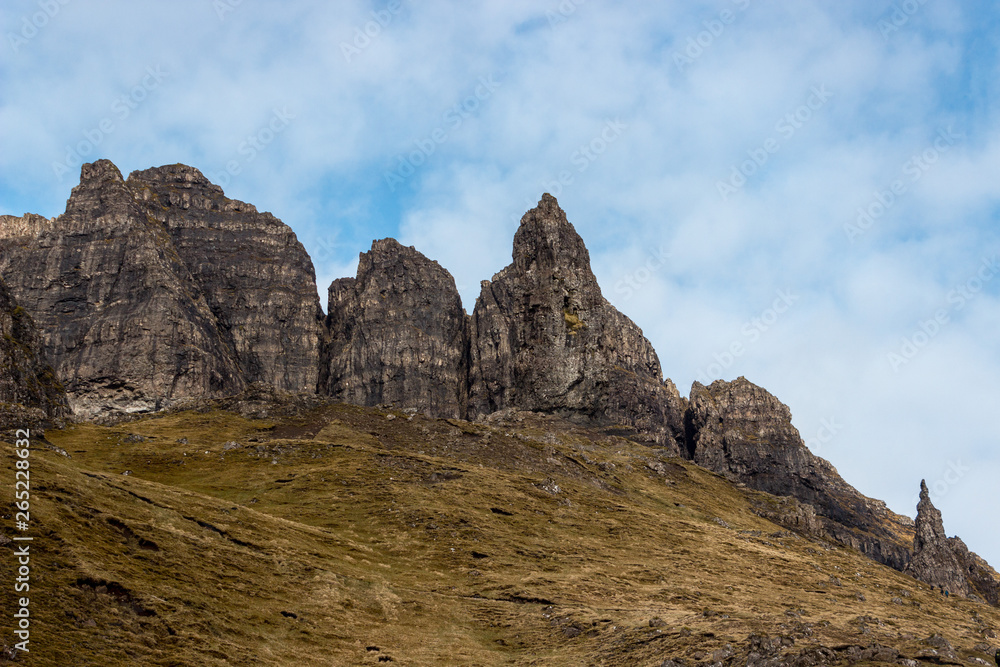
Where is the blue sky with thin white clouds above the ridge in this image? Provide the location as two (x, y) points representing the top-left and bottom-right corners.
(0, 0), (1000, 566)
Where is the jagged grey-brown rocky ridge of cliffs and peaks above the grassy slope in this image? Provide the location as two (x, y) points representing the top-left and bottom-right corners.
(0, 160), (997, 604)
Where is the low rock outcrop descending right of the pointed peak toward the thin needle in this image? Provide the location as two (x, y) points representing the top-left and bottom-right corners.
(685, 377), (912, 569)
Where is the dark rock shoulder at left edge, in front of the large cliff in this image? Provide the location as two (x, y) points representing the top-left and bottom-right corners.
(0, 279), (67, 422)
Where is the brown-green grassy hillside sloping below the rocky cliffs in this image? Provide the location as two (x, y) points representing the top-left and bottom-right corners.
(0, 405), (1000, 665)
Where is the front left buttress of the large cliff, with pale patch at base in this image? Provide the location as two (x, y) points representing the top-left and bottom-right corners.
(0, 160), (243, 417)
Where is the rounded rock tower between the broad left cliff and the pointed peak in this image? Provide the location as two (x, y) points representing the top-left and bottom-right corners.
(321, 239), (469, 417)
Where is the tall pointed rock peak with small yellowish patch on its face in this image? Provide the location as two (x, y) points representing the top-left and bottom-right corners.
(469, 194), (683, 452)
